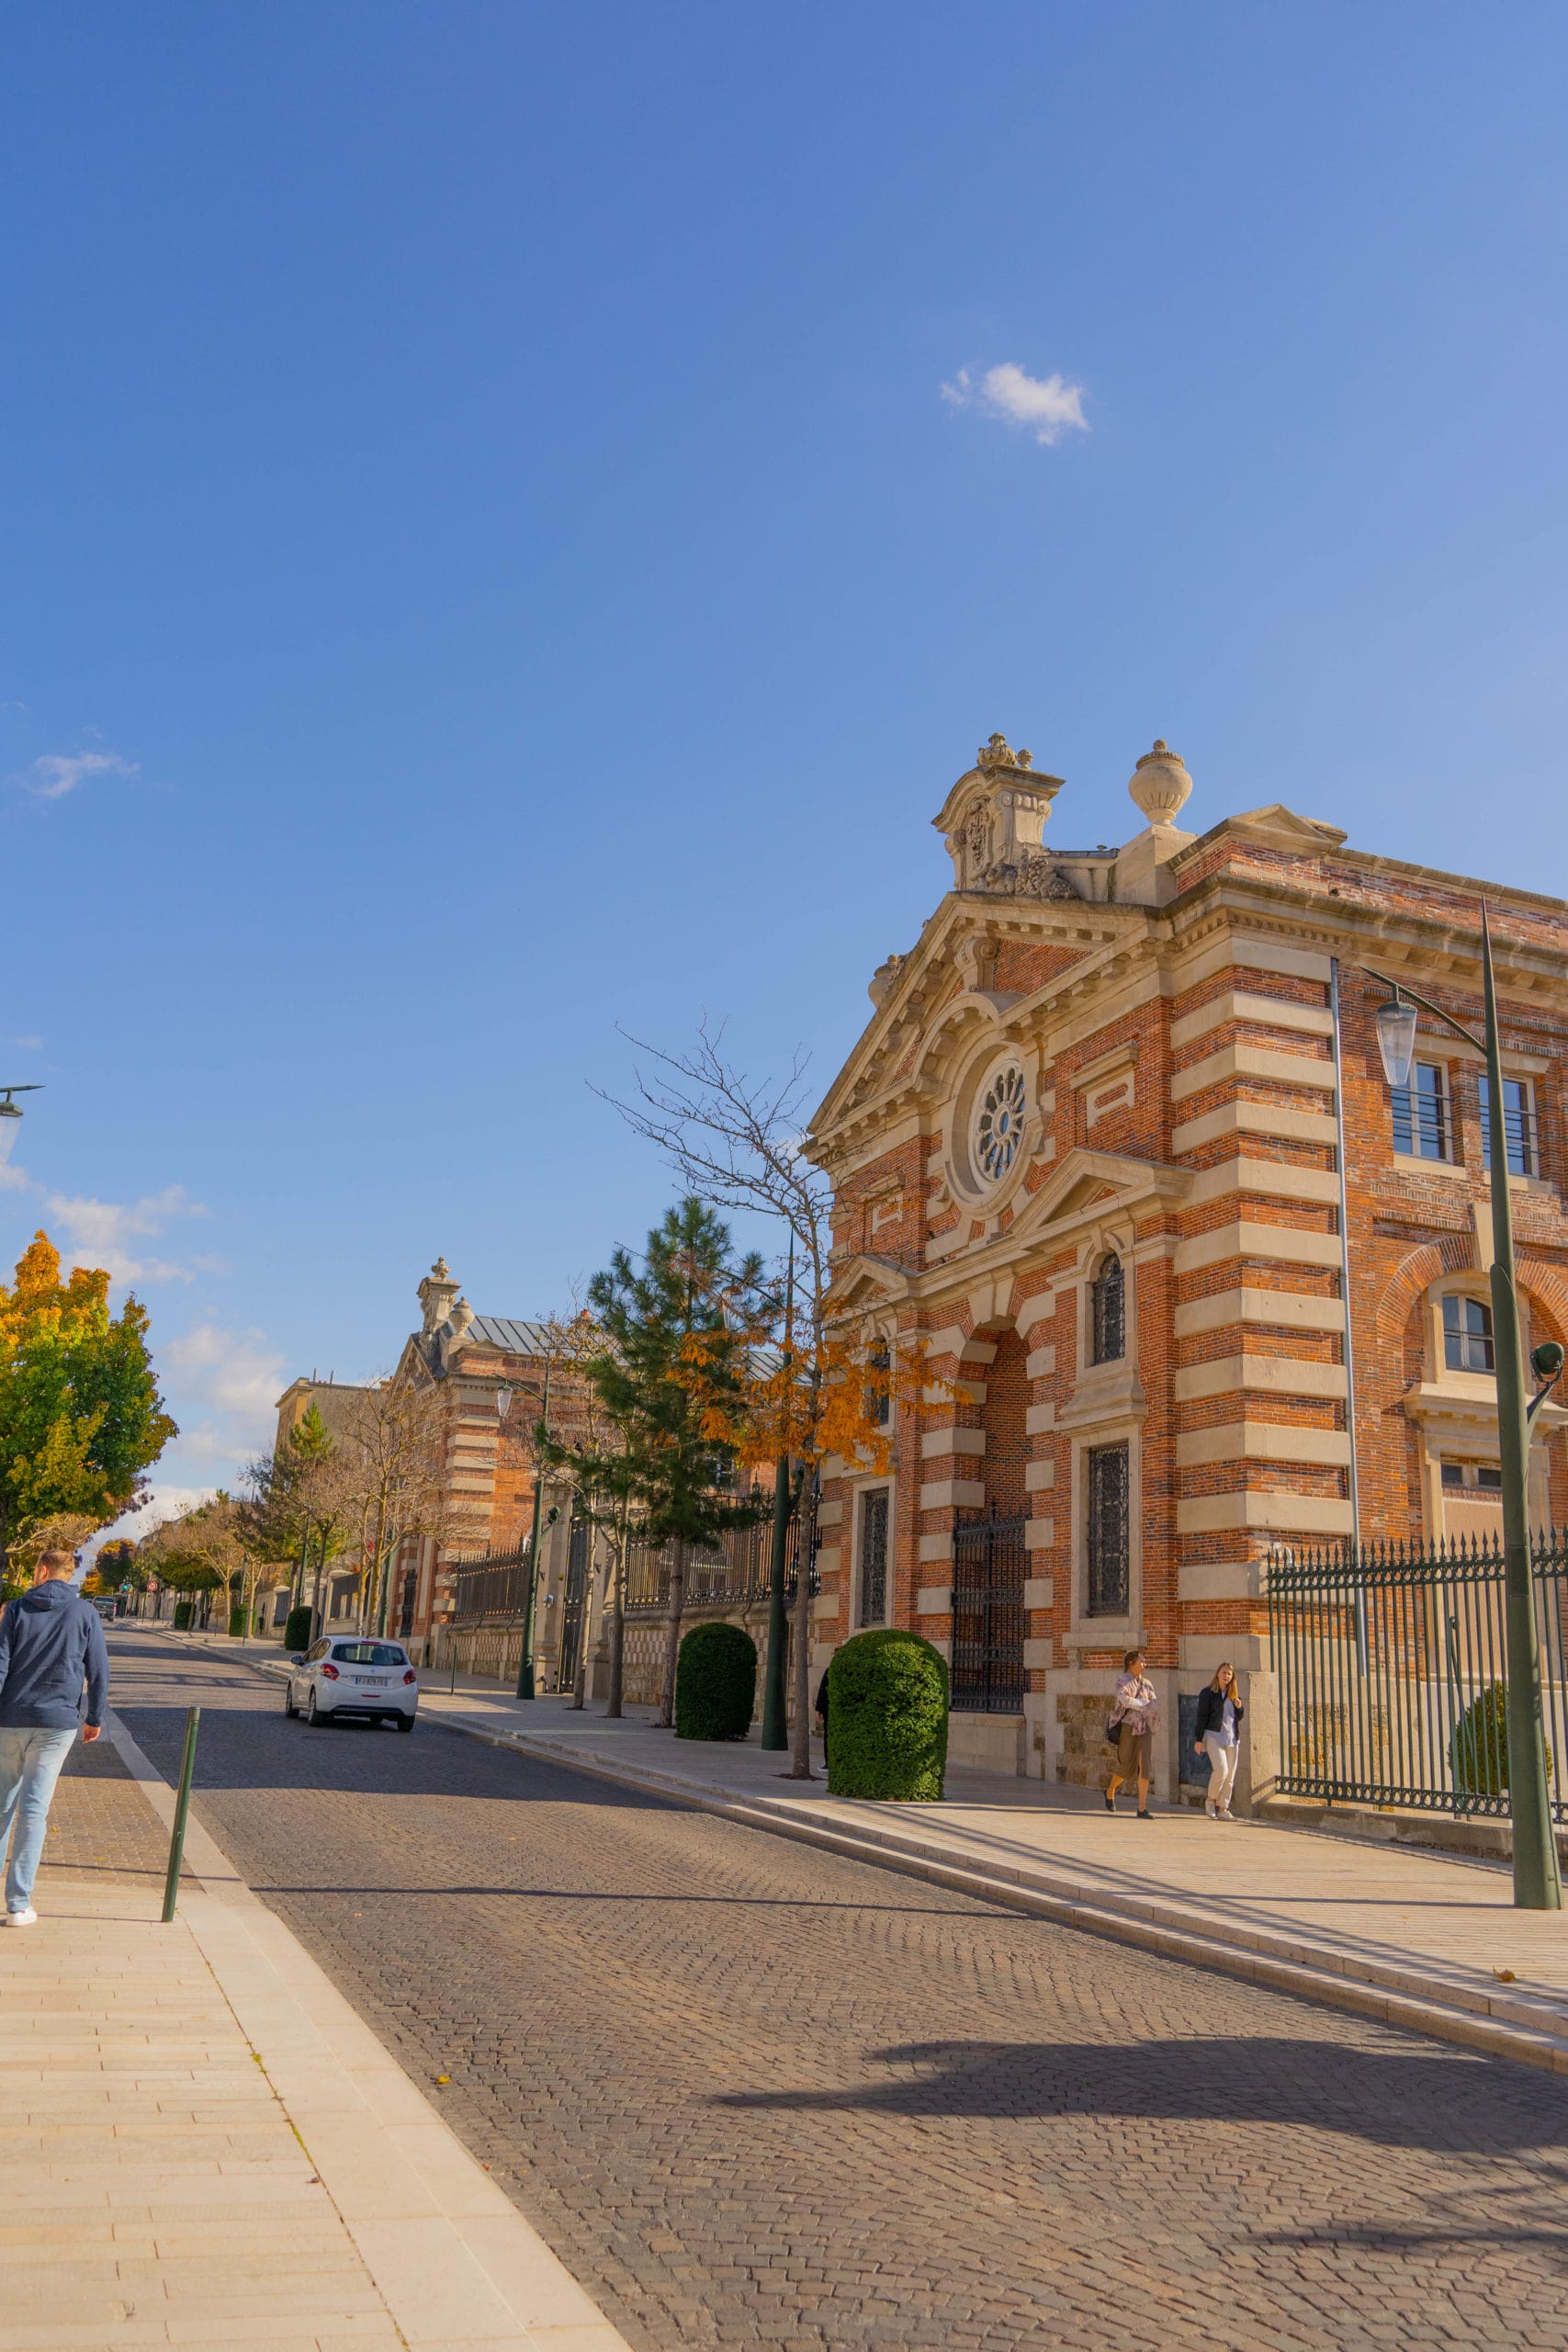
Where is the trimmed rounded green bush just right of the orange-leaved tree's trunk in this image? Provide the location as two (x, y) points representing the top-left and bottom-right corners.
(828, 1625), (947, 1804)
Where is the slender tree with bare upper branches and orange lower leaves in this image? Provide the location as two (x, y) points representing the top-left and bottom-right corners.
(611, 1025), (919, 1781)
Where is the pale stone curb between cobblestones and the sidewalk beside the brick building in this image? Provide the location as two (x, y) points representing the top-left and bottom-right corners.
(160, 1637), (1568, 2075)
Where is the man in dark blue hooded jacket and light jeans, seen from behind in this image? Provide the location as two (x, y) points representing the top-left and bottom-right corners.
(0, 1553), (108, 1927)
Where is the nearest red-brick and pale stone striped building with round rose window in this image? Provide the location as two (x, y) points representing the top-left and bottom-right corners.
(811, 736), (1568, 1797)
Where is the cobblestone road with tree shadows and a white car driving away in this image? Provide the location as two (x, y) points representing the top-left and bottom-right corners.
(113, 1633), (1568, 2352)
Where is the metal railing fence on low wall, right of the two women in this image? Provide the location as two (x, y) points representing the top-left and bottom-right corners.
(1269, 1533), (1568, 1820)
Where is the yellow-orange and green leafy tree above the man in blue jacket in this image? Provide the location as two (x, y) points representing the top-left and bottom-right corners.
(0, 1232), (179, 1550)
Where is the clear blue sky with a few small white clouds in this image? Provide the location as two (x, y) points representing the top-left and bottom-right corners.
(0, 0), (1568, 1514)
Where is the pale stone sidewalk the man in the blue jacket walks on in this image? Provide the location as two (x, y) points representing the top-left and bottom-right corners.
(0, 1719), (626, 2352)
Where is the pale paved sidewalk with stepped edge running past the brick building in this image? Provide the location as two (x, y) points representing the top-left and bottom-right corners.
(400, 1677), (1568, 2075)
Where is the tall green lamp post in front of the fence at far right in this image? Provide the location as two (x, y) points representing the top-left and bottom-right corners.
(1345, 906), (1563, 1910)
